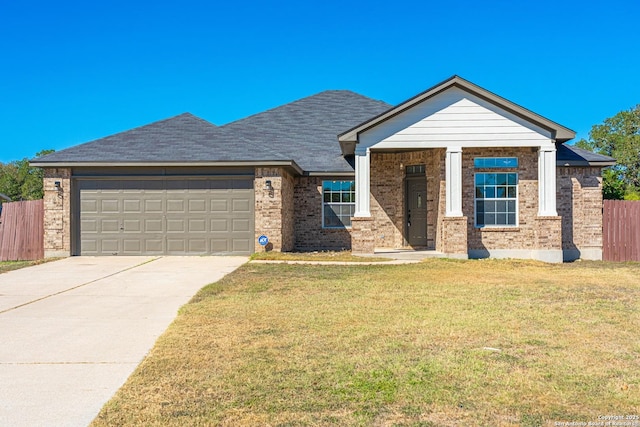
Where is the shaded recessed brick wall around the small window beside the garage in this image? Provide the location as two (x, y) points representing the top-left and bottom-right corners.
(293, 176), (355, 250)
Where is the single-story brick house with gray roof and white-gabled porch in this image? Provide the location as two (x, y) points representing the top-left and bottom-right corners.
(31, 76), (614, 262)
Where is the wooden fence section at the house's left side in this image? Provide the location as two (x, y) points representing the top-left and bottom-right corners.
(0, 200), (44, 261)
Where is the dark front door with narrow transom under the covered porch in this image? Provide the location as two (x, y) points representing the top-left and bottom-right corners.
(405, 169), (427, 246)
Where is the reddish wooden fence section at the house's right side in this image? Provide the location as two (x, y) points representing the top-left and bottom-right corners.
(602, 200), (640, 261)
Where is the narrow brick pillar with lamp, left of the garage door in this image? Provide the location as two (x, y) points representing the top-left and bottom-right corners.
(43, 168), (71, 258)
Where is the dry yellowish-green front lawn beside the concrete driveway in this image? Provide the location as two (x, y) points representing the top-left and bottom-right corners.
(94, 260), (640, 426)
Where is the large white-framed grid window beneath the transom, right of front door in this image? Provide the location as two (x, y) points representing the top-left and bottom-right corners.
(475, 173), (518, 227)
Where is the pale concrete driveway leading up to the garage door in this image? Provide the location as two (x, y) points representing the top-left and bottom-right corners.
(0, 256), (247, 426)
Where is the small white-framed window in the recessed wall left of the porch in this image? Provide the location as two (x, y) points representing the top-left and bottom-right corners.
(322, 181), (356, 228)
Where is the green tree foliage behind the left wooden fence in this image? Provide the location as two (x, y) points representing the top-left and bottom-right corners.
(0, 150), (54, 201)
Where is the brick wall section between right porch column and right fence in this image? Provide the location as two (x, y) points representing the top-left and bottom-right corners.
(556, 167), (602, 261)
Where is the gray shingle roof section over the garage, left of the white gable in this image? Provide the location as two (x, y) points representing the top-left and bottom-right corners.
(35, 91), (390, 172)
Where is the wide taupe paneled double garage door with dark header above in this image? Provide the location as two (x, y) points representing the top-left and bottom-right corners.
(76, 178), (254, 255)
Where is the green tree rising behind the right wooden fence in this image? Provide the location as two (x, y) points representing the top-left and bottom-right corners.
(576, 104), (640, 199)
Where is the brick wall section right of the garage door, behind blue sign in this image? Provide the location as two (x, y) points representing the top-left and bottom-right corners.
(254, 168), (295, 252)
